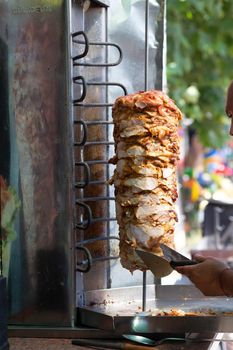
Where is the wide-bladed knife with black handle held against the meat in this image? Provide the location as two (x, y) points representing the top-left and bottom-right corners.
(135, 249), (197, 278)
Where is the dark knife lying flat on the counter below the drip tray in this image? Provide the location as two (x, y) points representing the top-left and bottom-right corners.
(72, 339), (156, 350)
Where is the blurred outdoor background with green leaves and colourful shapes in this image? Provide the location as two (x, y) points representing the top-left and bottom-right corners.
(167, 0), (233, 253)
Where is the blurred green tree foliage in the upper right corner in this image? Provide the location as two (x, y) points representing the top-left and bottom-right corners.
(167, 0), (233, 148)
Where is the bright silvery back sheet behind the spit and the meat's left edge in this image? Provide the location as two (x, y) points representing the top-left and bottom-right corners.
(108, 0), (165, 288)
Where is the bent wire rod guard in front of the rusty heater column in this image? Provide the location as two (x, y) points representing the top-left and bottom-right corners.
(72, 27), (127, 272)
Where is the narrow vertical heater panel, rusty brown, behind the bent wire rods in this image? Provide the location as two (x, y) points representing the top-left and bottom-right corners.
(72, 1), (109, 295)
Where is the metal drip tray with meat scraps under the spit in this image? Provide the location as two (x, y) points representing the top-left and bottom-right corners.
(78, 285), (233, 334)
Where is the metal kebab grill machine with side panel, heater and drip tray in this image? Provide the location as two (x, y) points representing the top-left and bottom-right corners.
(0, 0), (233, 338)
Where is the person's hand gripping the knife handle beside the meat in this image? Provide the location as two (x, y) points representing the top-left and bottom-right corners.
(176, 255), (228, 296)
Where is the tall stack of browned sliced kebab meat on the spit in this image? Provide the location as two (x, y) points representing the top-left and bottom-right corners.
(110, 90), (182, 272)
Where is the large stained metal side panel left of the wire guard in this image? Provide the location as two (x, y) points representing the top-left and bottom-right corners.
(0, 0), (74, 326)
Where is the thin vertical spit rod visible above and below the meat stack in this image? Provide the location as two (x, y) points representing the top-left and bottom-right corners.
(142, 0), (149, 311)
